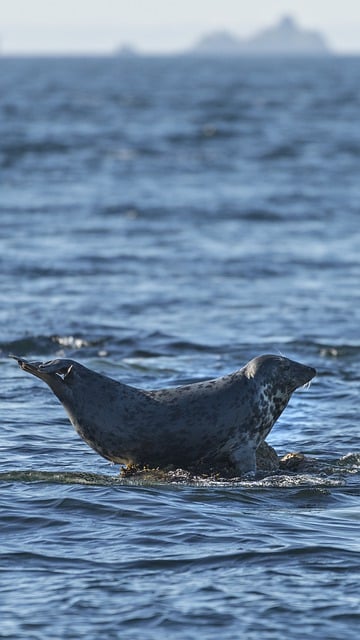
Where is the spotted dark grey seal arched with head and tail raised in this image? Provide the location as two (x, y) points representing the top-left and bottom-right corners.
(11, 355), (316, 475)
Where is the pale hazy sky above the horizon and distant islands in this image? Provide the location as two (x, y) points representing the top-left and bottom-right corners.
(0, 0), (360, 54)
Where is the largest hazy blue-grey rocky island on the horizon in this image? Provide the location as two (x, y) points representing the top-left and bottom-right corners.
(191, 16), (330, 56)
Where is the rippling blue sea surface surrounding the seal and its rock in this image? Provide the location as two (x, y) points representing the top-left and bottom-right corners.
(0, 57), (360, 640)
